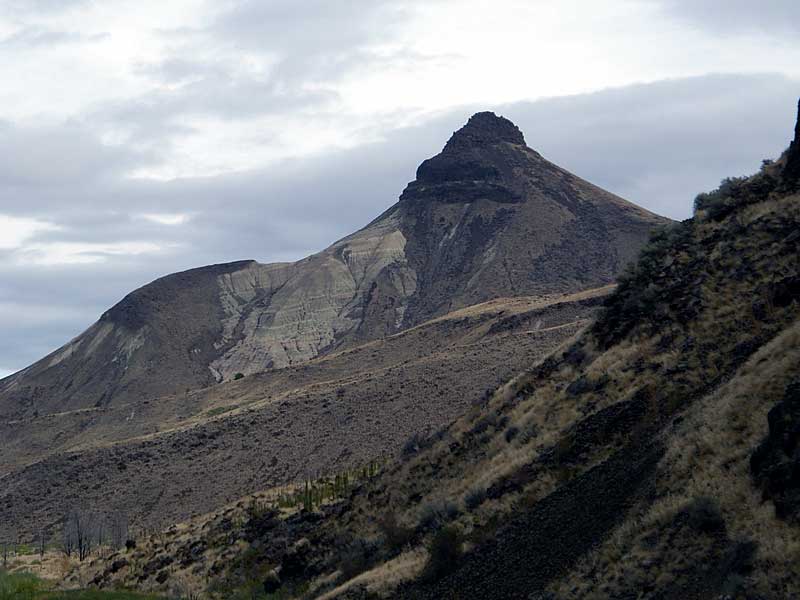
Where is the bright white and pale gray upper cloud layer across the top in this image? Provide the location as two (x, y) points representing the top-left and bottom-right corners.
(0, 0), (800, 179)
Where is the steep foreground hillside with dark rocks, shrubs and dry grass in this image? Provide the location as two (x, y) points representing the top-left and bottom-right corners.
(84, 101), (800, 600)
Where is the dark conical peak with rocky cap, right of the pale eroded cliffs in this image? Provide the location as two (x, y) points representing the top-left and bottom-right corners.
(396, 113), (668, 326)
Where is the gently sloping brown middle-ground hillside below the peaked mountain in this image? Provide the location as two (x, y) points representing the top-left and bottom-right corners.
(0, 286), (612, 541)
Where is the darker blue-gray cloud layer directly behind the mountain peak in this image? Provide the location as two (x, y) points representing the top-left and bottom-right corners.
(0, 75), (800, 369)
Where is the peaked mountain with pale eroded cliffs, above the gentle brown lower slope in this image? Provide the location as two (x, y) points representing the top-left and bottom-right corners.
(0, 113), (667, 419)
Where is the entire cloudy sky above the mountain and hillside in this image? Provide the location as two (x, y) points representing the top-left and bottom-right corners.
(0, 0), (800, 376)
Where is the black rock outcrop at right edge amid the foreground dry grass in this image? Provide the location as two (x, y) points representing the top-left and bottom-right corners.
(750, 380), (800, 523)
